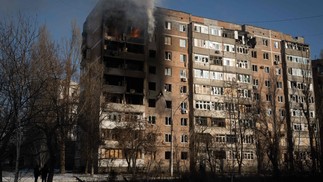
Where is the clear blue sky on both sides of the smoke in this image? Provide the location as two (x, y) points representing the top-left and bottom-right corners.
(0, 0), (323, 59)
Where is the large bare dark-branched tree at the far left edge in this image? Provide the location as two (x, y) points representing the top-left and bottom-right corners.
(0, 14), (38, 181)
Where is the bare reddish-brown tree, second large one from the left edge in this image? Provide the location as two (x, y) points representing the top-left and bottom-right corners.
(29, 26), (63, 181)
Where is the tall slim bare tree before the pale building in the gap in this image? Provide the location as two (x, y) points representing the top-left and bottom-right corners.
(57, 19), (81, 174)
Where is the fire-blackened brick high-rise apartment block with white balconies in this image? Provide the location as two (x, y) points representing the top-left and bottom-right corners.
(82, 1), (317, 175)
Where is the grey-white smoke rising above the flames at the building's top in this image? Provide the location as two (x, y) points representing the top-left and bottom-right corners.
(102, 0), (155, 38)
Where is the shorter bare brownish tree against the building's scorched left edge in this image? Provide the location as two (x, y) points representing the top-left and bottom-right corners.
(78, 60), (106, 174)
